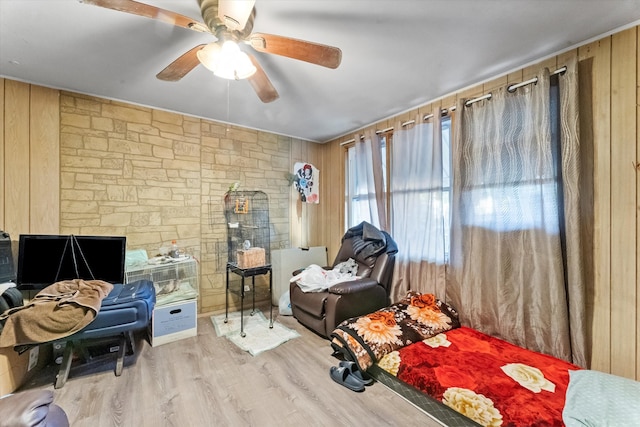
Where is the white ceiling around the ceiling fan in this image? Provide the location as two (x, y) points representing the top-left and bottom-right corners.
(0, 0), (640, 142)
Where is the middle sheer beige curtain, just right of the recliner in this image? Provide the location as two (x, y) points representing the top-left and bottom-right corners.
(390, 110), (448, 302)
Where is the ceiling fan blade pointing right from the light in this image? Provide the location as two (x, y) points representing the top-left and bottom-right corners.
(249, 33), (342, 68)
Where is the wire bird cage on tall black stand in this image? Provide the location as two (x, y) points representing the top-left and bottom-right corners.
(224, 191), (271, 269)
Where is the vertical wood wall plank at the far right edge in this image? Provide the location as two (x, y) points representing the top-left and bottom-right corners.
(611, 28), (638, 378)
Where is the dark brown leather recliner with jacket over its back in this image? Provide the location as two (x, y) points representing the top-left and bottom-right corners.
(289, 222), (398, 338)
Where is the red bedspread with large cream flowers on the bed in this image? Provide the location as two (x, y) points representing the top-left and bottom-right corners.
(378, 327), (581, 426)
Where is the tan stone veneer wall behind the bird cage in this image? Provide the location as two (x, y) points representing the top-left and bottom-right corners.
(60, 92), (296, 313)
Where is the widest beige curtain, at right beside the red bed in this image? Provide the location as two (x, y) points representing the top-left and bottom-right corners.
(447, 55), (587, 366)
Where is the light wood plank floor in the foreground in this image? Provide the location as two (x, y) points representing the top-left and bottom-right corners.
(22, 308), (440, 427)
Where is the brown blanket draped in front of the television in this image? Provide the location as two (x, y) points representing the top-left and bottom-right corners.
(0, 279), (113, 347)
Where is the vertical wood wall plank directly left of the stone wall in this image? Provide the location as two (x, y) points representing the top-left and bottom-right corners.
(29, 86), (60, 234)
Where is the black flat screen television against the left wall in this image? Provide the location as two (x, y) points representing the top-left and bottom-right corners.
(16, 234), (127, 290)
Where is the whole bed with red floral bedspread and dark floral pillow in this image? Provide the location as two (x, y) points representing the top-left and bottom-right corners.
(331, 292), (640, 426)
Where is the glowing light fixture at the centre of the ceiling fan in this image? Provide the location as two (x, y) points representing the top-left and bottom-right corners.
(197, 40), (256, 80)
